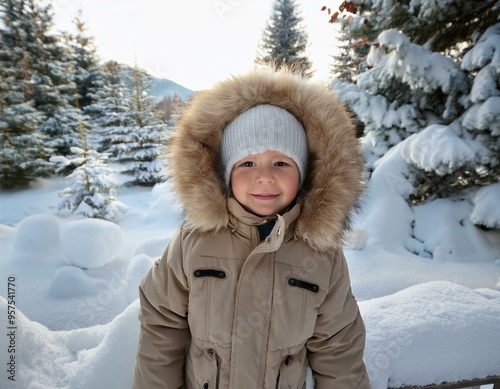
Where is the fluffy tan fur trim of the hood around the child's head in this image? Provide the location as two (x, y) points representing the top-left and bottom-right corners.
(167, 69), (364, 251)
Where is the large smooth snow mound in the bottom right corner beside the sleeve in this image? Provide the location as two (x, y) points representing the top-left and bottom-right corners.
(359, 281), (500, 389)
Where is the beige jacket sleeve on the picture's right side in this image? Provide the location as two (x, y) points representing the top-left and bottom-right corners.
(307, 250), (370, 389)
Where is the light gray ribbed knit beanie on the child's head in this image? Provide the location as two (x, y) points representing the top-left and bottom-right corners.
(220, 104), (308, 187)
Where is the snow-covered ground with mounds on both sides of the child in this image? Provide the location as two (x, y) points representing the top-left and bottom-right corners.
(0, 146), (500, 389)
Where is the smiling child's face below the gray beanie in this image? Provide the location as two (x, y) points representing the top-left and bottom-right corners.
(231, 150), (300, 216)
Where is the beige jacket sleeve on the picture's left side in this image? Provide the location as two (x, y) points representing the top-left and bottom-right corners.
(133, 230), (190, 389)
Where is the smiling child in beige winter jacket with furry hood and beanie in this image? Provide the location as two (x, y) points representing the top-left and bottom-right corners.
(134, 69), (369, 389)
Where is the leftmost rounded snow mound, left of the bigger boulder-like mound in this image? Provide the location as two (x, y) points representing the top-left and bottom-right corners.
(14, 214), (64, 264)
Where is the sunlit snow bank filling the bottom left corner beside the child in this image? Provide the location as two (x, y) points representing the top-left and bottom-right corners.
(0, 297), (125, 389)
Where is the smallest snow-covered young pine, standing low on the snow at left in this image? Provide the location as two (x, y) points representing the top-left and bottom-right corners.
(51, 113), (128, 221)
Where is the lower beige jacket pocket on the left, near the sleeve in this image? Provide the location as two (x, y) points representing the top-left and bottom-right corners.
(186, 341), (219, 389)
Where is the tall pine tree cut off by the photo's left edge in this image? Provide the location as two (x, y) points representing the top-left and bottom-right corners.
(0, 0), (51, 189)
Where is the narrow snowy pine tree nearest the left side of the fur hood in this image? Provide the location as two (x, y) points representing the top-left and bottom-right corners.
(111, 65), (168, 186)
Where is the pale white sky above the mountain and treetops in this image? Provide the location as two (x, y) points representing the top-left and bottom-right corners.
(50, 0), (338, 90)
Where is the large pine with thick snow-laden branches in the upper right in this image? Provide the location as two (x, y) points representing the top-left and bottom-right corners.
(330, 0), (500, 201)
